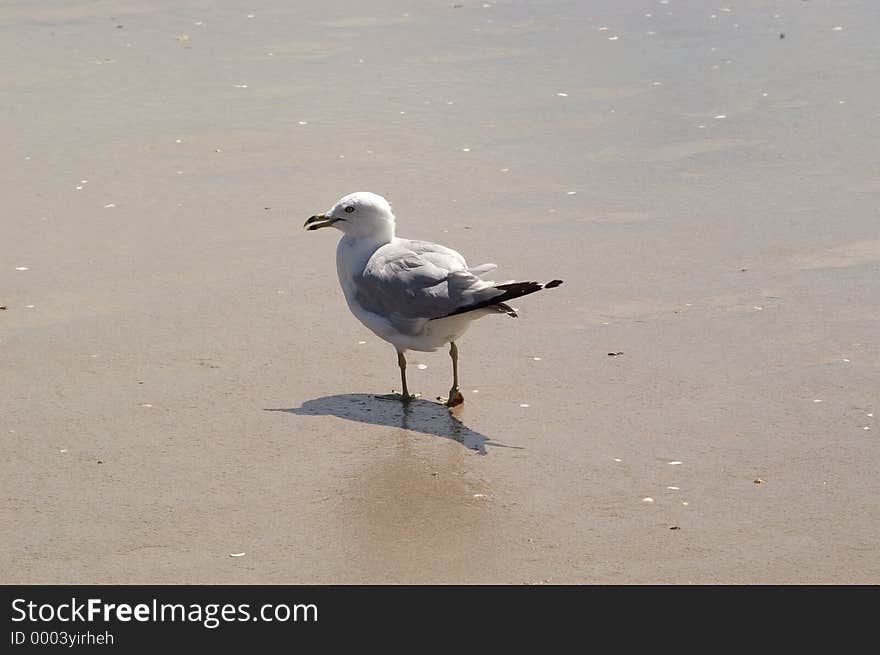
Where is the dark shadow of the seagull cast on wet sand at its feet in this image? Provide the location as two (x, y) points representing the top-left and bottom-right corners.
(266, 393), (516, 455)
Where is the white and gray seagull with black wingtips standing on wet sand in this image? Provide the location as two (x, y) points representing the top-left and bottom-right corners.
(303, 191), (562, 407)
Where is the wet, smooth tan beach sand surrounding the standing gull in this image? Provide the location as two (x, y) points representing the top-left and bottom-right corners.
(0, 0), (880, 584)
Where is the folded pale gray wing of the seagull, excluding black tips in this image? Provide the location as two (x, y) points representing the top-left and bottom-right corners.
(354, 240), (501, 334)
